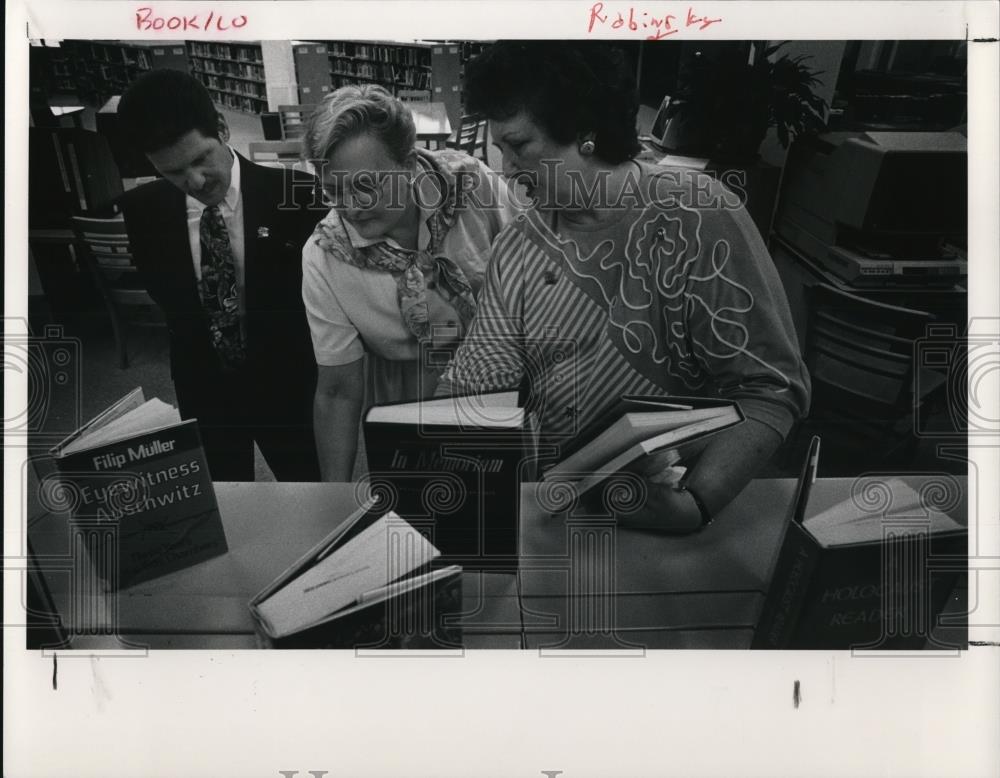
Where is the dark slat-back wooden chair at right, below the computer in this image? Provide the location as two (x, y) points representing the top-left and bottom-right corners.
(788, 284), (944, 468)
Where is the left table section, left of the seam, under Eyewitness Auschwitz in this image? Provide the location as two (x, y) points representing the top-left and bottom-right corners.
(28, 482), (520, 650)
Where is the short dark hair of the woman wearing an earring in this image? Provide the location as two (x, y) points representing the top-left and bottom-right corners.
(465, 41), (640, 164)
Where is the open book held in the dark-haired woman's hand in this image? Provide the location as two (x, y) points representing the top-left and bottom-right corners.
(544, 395), (743, 494)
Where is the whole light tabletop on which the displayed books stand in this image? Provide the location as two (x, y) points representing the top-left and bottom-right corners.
(28, 476), (967, 651)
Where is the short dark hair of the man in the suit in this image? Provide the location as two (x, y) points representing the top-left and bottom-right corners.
(118, 69), (219, 154)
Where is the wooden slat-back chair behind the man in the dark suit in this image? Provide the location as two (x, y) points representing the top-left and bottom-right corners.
(73, 216), (165, 369)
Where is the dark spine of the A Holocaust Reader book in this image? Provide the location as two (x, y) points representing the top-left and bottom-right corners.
(750, 522), (820, 648)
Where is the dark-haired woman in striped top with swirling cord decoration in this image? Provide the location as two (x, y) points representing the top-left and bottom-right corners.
(438, 41), (809, 531)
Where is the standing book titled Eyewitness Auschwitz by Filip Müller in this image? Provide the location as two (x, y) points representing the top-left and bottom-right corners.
(50, 388), (228, 589)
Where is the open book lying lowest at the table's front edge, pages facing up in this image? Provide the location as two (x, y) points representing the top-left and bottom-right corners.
(250, 499), (462, 649)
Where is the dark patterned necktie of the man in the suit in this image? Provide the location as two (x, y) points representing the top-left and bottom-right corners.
(200, 205), (246, 369)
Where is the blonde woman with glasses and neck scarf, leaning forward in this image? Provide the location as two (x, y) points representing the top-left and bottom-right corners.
(302, 85), (511, 481)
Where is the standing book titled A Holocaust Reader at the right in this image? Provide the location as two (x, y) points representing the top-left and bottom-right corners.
(751, 440), (968, 650)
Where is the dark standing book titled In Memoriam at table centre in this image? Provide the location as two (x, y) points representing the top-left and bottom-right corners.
(364, 392), (536, 569)
